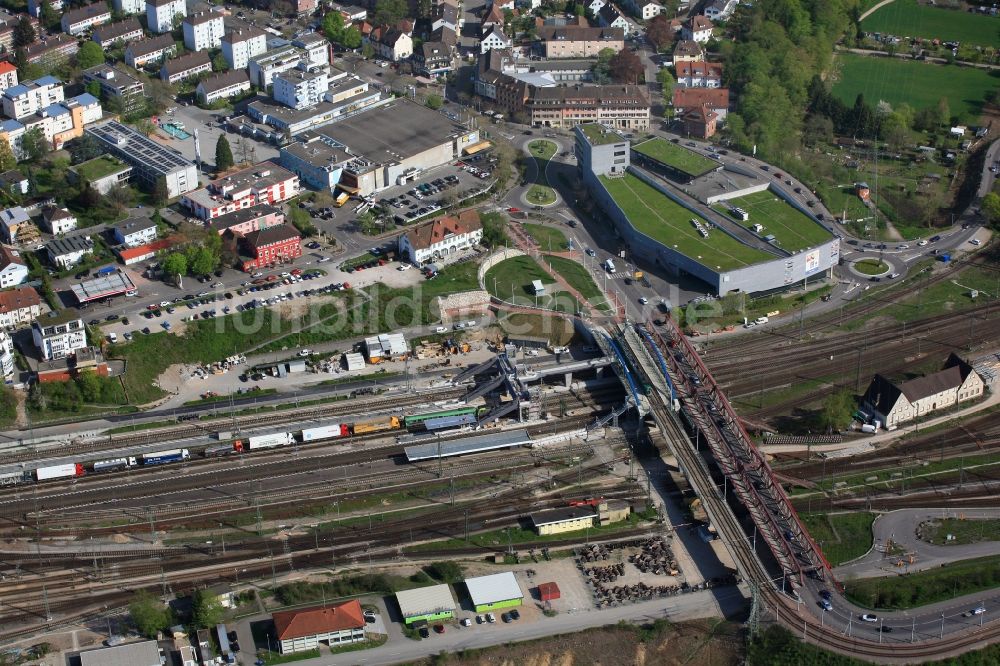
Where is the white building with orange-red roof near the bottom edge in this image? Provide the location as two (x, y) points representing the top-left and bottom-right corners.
(273, 599), (365, 654)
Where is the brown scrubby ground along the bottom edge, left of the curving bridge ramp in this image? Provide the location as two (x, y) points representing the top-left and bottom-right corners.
(406, 621), (744, 666)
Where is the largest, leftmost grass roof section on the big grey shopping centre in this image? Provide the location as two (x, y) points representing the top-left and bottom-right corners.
(601, 173), (776, 270)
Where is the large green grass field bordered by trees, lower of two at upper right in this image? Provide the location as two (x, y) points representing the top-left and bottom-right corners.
(833, 53), (1000, 122)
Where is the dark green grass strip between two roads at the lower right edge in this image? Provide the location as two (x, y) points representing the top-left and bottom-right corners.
(844, 555), (1000, 610)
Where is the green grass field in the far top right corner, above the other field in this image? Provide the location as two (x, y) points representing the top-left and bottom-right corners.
(861, 0), (1000, 46)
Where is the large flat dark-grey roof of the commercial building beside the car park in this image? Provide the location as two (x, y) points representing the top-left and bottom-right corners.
(318, 99), (469, 164)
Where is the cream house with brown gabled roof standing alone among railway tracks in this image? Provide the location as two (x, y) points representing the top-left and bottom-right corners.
(861, 354), (986, 430)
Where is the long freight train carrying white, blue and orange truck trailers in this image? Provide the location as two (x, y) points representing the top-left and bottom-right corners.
(0, 406), (486, 486)
